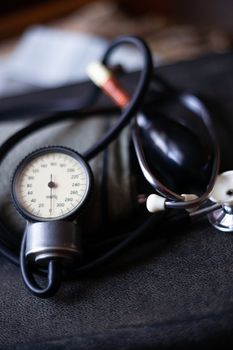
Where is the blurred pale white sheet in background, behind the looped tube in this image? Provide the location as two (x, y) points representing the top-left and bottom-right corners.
(5, 26), (141, 87)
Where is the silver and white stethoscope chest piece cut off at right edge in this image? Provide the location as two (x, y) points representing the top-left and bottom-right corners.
(208, 170), (233, 232)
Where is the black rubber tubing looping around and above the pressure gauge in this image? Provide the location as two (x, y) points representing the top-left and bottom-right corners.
(0, 37), (158, 296)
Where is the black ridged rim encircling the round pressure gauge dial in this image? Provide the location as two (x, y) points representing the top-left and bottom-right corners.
(11, 146), (93, 222)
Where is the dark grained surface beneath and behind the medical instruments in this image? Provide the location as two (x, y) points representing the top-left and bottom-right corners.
(0, 53), (233, 350)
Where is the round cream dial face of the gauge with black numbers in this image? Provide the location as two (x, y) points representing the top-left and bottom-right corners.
(13, 148), (90, 221)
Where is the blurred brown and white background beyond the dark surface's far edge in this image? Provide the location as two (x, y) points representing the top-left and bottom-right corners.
(0, 0), (233, 96)
